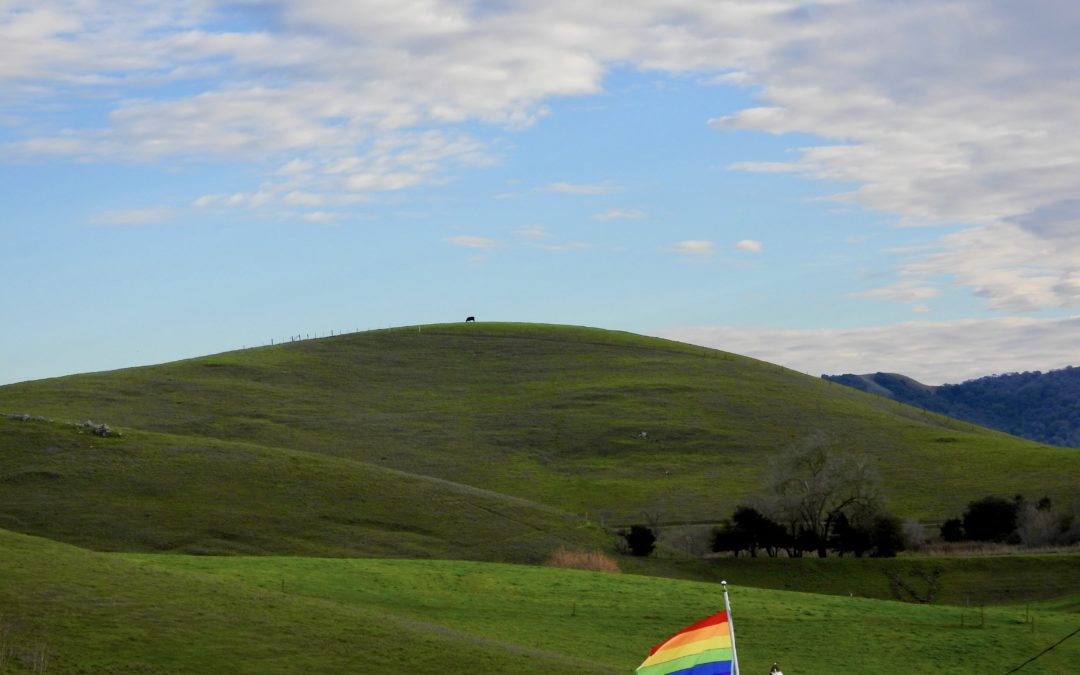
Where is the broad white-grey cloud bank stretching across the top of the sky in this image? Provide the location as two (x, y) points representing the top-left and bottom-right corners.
(6, 0), (1080, 311)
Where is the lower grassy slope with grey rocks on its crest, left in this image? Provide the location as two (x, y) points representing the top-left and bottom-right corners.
(0, 419), (608, 563)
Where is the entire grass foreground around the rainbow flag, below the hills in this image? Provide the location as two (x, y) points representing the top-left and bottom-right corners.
(0, 531), (1080, 675)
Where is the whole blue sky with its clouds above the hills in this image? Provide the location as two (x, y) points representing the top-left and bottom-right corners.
(0, 0), (1080, 383)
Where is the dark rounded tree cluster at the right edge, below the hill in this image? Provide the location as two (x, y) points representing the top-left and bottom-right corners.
(941, 495), (1080, 546)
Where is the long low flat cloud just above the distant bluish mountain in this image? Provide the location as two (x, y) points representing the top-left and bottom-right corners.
(660, 316), (1080, 384)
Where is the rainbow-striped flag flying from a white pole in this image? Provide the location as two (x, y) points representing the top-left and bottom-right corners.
(637, 611), (733, 675)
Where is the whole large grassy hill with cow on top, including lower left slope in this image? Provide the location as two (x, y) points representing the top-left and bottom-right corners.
(0, 323), (1080, 561)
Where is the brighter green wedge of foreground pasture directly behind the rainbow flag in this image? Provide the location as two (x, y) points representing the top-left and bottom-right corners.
(144, 556), (1080, 674)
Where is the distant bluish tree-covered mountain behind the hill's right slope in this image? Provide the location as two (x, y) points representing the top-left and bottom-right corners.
(822, 366), (1080, 447)
